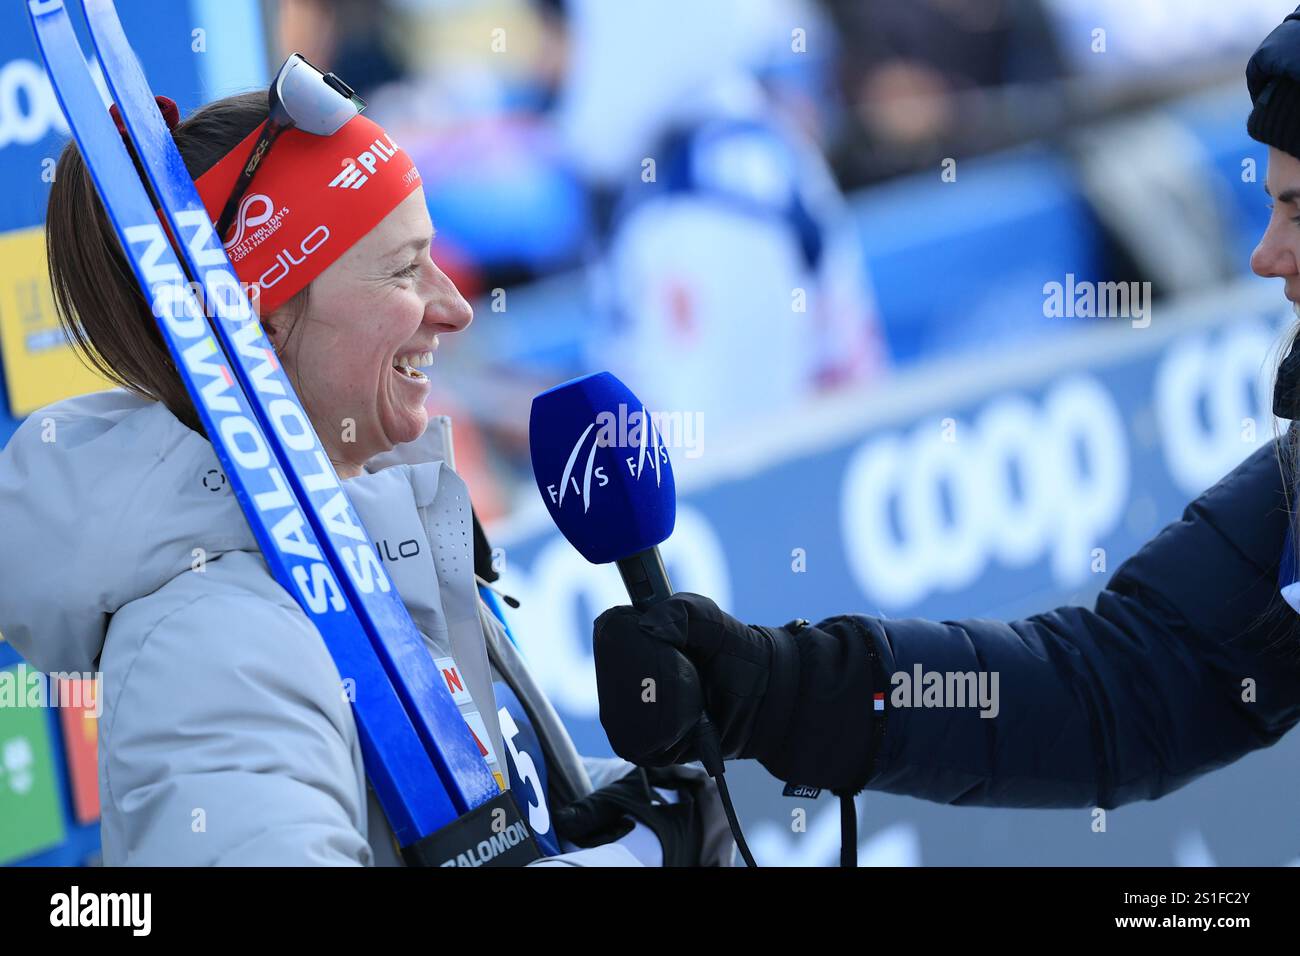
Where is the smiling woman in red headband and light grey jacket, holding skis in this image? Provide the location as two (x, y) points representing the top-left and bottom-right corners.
(0, 56), (732, 865)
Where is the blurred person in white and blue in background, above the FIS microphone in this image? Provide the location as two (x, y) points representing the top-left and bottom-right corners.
(589, 74), (884, 434)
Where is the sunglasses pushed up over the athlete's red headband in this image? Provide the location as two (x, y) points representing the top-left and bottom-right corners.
(217, 53), (365, 239)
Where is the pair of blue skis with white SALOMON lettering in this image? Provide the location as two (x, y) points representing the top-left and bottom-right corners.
(27, 0), (540, 865)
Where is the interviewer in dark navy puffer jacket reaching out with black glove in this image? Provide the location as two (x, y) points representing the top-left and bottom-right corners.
(594, 10), (1300, 808)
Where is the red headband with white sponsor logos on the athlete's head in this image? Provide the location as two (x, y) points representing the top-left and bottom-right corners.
(195, 116), (420, 315)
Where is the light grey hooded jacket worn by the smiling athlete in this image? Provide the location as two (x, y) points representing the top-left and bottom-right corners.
(0, 390), (725, 865)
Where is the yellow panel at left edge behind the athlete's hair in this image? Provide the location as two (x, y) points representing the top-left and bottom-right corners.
(0, 226), (109, 418)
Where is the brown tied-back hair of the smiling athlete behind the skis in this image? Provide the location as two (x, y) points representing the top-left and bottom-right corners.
(46, 90), (309, 434)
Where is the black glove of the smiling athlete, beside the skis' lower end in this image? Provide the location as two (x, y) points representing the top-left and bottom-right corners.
(553, 767), (711, 866)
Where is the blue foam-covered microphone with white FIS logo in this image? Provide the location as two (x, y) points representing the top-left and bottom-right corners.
(528, 372), (677, 611)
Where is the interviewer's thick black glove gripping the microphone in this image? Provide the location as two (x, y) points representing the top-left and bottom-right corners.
(593, 592), (876, 792)
